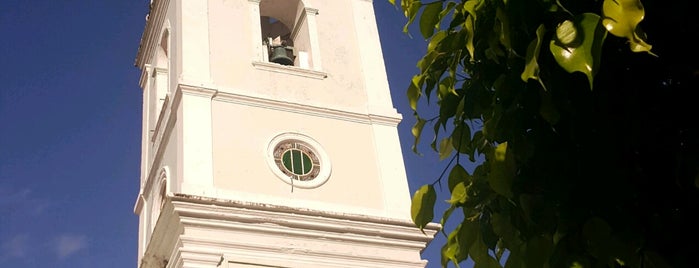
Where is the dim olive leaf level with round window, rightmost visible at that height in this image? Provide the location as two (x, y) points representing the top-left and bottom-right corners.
(488, 142), (516, 199)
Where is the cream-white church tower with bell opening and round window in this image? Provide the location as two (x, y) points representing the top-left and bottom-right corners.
(134, 0), (438, 268)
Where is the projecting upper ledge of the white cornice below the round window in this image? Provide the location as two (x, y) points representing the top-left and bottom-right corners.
(171, 194), (440, 241)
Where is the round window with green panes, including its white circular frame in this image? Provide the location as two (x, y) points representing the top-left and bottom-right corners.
(267, 133), (330, 188)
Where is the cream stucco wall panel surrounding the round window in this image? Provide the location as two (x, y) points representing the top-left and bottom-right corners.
(212, 101), (383, 214)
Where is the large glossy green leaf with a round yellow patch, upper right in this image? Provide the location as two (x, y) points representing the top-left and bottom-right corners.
(549, 13), (607, 89)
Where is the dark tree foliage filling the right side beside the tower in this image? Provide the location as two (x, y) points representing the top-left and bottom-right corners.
(388, 0), (699, 268)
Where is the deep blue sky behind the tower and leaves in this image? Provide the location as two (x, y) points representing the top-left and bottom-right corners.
(0, 0), (464, 268)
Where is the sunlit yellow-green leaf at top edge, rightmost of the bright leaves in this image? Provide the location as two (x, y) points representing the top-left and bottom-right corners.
(602, 0), (655, 56)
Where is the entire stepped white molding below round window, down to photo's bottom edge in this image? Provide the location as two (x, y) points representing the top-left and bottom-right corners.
(161, 194), (440, 268)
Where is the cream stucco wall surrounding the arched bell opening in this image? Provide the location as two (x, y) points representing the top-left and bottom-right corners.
(208, 0), (367, 111)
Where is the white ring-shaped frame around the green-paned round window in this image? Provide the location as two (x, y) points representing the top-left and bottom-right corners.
(266, 133), (332, 189)
